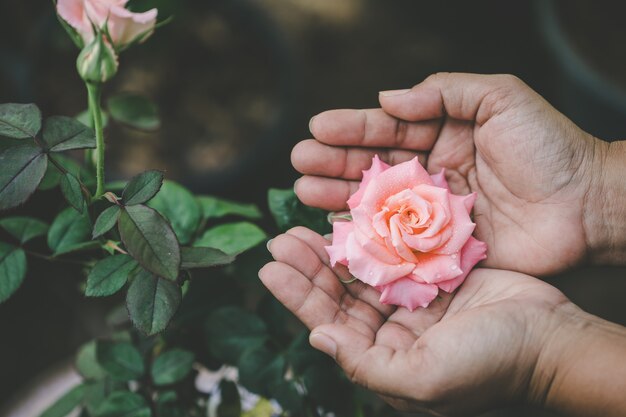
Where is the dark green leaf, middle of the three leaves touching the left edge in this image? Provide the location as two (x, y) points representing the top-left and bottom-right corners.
(0, 145), (48, 210)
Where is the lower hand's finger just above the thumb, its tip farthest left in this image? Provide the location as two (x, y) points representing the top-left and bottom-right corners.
(259, 262), (374, 337)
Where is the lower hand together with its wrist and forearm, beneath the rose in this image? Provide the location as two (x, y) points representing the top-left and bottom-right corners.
(259, 227), (626, 417)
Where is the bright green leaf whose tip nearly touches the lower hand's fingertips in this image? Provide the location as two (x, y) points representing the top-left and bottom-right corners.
(193, 222), (267, 255)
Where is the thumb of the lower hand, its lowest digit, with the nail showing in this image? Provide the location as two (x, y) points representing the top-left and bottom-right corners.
(309, 324), (422, 397)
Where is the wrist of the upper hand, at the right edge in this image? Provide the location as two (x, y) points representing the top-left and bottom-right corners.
(583, 139), (626, 265)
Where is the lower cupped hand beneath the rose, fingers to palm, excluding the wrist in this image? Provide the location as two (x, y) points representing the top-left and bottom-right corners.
(259, 227), (571, 415)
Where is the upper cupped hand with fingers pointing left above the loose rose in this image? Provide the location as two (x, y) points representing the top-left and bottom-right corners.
(292, 74), (626, 275)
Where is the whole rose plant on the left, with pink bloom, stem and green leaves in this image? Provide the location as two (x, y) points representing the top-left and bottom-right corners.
(0, 0), (402, 417)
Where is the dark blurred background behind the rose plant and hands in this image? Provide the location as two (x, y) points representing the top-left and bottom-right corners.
(0, 0), (626, 416)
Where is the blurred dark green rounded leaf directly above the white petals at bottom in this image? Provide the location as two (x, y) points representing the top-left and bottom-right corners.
(205, 307), (268, 364)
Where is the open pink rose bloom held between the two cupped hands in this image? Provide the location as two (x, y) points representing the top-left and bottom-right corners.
(326, 156), (487, 311)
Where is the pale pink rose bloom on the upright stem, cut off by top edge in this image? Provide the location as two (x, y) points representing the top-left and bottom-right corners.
(57, 0), (157, 49)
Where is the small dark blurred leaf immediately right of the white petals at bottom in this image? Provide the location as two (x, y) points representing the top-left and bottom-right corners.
(237, 346), (286, 397)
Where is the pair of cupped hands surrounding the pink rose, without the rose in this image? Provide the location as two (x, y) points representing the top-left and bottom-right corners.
(259, 74), (623, 416)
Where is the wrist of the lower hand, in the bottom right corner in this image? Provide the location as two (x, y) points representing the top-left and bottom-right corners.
(528, 303), (626, 417)
